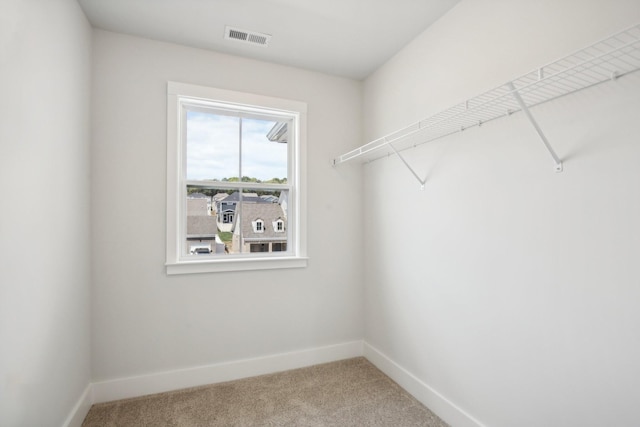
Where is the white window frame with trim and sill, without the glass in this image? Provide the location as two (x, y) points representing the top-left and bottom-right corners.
(166, 82), (308, 275)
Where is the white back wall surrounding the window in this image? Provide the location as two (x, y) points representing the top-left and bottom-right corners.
(92, 30), (364, 381)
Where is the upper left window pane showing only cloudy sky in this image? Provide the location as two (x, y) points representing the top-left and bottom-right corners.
(186, 111), (240, 181)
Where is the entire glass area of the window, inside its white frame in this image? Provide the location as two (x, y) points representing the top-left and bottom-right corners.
(182, 109), (289, 258)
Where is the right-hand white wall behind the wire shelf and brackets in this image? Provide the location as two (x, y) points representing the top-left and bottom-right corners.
(364, 0), (640, 427)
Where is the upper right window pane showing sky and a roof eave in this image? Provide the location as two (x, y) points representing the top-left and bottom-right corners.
(242, 118), (289, 184)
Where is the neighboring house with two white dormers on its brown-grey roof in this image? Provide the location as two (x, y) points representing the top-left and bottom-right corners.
(231, 202), (287, 253)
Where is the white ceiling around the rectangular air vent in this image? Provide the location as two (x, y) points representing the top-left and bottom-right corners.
(78, 0), (459, 80)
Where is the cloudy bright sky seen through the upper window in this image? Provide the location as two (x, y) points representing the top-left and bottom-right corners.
(187, 111), (287, 181)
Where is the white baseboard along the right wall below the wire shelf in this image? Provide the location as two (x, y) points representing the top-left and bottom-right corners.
(364, 342), (485, 427)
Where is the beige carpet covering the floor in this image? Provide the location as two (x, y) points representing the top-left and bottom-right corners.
(82, 357), (447, 427)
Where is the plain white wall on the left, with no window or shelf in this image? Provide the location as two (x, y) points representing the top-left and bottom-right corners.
(0, 0), (91, 426)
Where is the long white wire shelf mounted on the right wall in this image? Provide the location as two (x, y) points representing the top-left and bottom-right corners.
(333, 24), (640, 165)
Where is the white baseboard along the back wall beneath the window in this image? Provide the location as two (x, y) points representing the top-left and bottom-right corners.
(93, 341), (363, 403)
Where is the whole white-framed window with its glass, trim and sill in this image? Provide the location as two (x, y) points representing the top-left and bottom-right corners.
(167, 82), (306, 274)
